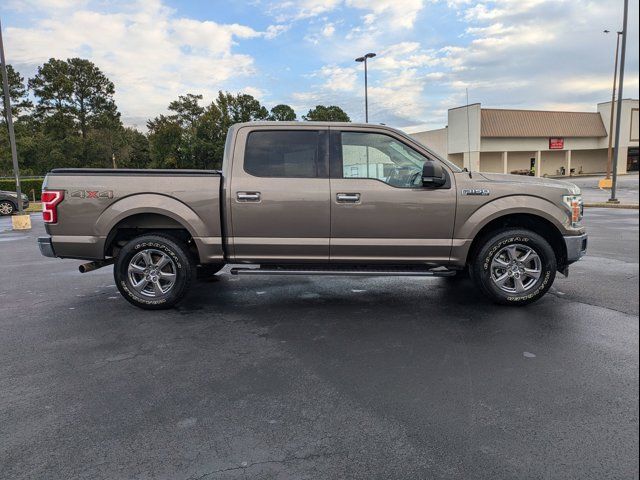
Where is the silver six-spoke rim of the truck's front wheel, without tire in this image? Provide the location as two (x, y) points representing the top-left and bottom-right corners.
(491, 244), (542, 294)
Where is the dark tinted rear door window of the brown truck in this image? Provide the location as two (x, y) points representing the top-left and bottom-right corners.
(244, 130), (325, 178)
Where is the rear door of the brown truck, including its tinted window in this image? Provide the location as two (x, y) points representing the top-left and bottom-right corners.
(228, 125), (331, 263)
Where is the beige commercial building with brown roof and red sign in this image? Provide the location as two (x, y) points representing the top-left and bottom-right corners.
(412, 99), (638, 176)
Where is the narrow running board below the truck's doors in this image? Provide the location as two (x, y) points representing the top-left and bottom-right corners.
(229, 265), (456, 277)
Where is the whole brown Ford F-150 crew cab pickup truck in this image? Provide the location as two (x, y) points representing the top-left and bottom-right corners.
(38, 122), (587, 309)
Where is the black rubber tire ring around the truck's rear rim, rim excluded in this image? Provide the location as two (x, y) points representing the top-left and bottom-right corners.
(113, 235), (194, 310)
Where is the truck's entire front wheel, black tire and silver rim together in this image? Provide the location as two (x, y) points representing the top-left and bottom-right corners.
(470, 229), (557, 305)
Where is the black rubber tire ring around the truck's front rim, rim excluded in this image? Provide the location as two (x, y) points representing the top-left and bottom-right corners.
(473, 230), (557, 305)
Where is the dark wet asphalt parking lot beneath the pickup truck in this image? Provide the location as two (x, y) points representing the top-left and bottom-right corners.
(0, 209), (638, 479)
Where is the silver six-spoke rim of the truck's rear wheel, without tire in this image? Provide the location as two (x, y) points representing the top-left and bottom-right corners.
(127, 248), (178, 297)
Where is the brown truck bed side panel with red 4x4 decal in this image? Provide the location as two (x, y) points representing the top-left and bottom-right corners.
(43, 168), (223, 263)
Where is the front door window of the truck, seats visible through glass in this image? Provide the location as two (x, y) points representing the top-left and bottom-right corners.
(341, 132), (427, 188)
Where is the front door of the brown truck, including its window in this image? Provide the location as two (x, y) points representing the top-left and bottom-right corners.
(330, 127), (456, 265)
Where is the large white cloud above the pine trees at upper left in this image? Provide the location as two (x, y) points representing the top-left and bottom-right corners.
(5, 0), (286, 126)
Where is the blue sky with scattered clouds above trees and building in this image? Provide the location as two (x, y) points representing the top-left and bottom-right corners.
(0, 0), (638, 130)
